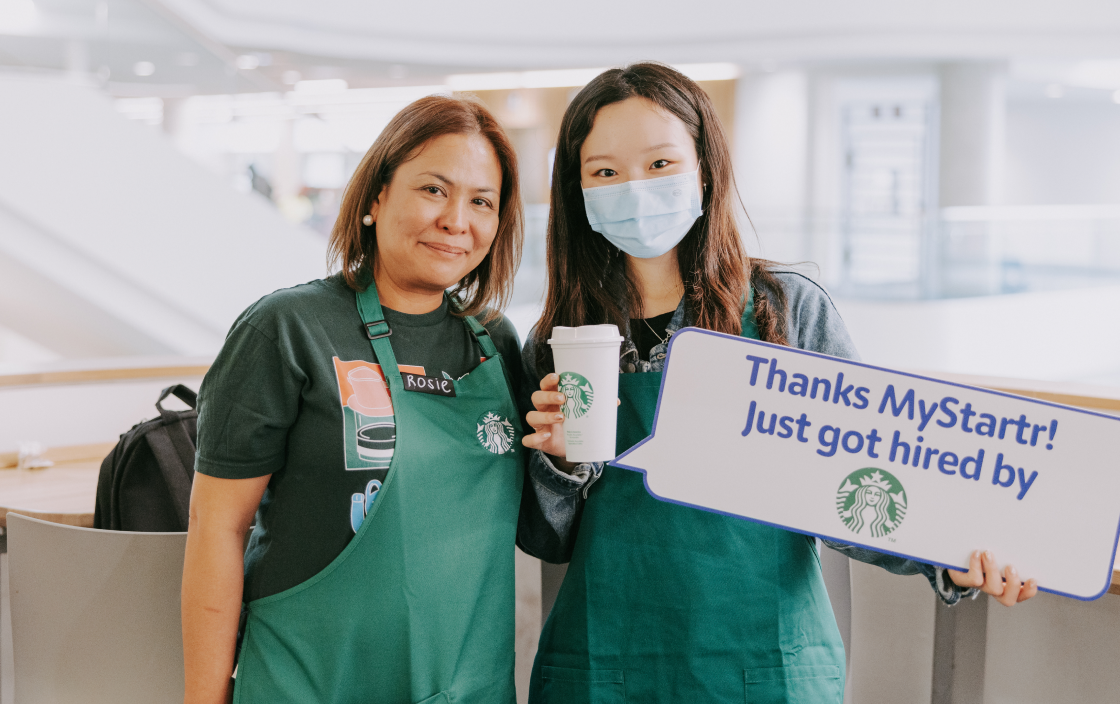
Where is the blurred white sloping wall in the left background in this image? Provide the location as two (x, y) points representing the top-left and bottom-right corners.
(0, 74), (326, 356)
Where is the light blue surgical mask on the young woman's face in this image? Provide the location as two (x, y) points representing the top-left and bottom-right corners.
(584, 167), (703, 259)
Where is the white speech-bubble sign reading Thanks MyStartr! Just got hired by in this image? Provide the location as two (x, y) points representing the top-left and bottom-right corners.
(610, 328), (1120, 600)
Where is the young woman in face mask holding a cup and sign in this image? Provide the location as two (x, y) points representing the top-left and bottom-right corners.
(519, 64), (1036, 704)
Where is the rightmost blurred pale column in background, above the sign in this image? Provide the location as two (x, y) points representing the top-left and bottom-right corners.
(939, 63), (1007, 207)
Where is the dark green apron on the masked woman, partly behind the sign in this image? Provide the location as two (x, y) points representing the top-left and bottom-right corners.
(530, 299), (844, 704)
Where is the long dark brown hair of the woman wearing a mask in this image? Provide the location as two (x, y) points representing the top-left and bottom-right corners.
(532, 62), (787, 372)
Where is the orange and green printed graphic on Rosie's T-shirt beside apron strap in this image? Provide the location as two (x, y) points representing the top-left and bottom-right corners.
(334, 357), (424, 470)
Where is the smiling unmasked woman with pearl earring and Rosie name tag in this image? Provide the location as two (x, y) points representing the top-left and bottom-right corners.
(183, 96), (525, 704)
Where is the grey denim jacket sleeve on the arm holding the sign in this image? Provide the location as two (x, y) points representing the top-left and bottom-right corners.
(774, 271), (976, 604)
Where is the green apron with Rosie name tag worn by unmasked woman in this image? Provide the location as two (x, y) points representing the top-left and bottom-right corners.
(234, 284), (524, 704)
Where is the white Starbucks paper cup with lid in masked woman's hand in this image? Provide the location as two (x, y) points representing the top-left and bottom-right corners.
(549, 325), (623, 462)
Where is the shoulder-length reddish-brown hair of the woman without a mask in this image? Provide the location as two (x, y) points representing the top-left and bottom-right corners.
(327, 95), (524, 318)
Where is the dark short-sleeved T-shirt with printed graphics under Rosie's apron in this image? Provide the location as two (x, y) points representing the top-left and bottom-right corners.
(195, 276), (522, 601)
